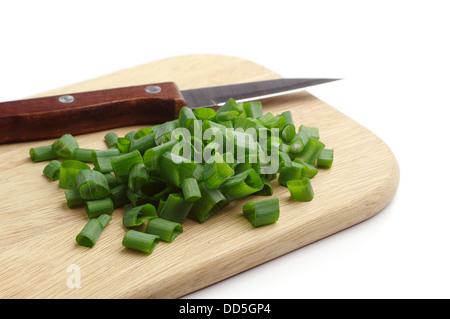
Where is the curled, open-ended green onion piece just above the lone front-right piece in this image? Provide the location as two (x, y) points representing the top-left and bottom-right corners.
(220, 168), (263, 199)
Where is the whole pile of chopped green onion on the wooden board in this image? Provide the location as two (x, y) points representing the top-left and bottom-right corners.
(30, 99), (333, 254)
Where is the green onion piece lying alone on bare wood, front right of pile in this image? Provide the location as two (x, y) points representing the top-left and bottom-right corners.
(242, 197), (280, 227)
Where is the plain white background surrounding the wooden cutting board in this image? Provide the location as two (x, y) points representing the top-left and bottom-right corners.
(0, 0), (450, 298)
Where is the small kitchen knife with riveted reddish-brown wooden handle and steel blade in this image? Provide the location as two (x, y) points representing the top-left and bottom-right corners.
(0, 78), (337, 144)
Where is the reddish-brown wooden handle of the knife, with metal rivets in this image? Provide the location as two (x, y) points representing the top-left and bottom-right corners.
(0, 82), (186, 144)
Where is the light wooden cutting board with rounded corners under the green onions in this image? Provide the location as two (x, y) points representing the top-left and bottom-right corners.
(0, 55), (399, 298)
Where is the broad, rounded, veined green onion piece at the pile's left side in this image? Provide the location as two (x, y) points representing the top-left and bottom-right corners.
(77, 169), (110, 200)
